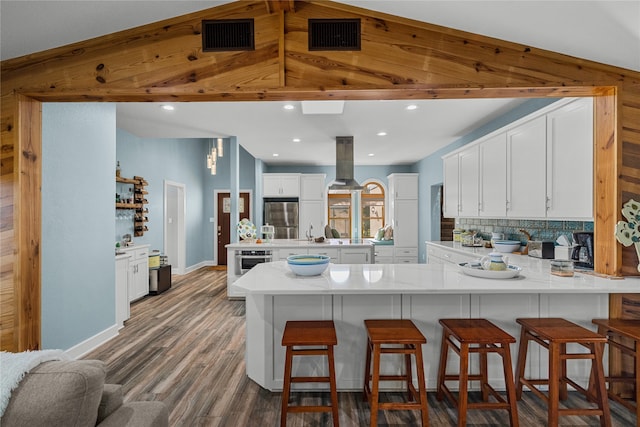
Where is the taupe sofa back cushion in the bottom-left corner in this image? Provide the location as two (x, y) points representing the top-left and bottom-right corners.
(1, 360), (106, 427)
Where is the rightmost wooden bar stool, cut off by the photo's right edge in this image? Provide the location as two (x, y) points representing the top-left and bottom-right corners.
(593, 319), (640, 423)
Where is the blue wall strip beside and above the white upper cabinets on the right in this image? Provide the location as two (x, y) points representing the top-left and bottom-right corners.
(412, 98), (558, 262)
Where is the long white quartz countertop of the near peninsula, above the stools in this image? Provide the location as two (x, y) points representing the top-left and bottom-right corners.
(232, 261), (640, 295)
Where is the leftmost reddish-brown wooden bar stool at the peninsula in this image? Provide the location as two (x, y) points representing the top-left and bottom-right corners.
(280, 320), (339, 427)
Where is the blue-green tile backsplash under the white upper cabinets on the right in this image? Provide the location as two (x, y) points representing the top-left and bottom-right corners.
(456, 218), (593, 243)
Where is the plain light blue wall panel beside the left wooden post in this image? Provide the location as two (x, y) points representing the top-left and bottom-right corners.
(42, 103), (116, 350)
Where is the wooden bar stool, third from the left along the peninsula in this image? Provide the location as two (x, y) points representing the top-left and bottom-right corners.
(436, 319), (518, 427)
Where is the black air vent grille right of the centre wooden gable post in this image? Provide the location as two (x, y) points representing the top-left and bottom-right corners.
(309, 19), (360, 50)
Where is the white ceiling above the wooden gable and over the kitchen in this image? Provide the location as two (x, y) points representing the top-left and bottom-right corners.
(0, 0), (640, 164)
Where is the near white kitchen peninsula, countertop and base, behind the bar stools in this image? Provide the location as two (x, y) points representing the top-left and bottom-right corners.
(232, 261), (640, 391)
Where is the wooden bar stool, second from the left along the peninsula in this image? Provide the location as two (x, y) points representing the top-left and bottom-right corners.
(364, 319), (429, 427)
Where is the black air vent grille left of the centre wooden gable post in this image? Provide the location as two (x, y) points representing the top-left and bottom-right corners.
(202, 19), (255, 52)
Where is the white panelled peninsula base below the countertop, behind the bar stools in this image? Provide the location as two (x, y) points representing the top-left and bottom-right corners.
(246, 293), (609, 391)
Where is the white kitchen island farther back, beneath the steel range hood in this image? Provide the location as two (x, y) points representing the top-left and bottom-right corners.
(226, 239), (375, 298)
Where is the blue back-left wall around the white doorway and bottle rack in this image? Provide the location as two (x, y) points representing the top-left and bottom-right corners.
(116, 129), (255, 268)
